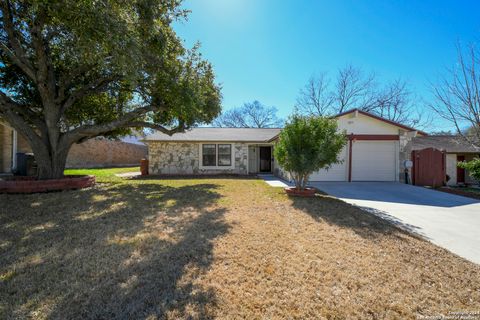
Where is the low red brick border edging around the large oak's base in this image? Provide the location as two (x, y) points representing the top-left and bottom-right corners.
(0, 176), (95, 193)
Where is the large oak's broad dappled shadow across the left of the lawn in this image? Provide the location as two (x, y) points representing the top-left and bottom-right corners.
(0, 183), (229, 319)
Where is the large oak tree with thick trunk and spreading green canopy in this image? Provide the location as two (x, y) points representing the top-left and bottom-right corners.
(0, 0), (221, 179)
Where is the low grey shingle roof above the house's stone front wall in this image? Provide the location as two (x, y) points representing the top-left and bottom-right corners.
(144, 128), (281, 142)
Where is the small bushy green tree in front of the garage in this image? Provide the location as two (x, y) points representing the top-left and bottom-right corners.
(275, 115), (346, 190)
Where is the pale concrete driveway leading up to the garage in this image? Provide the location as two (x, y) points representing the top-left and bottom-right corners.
(311, 182), (480, 264)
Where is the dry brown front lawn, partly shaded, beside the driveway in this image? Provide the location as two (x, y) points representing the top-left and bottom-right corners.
(0, 174), (480, 319)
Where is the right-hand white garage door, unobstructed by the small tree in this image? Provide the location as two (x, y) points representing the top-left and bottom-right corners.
(352, 141), (398, 181)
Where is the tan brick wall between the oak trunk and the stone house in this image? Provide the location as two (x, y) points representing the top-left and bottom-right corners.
(67, 139), (148, 168)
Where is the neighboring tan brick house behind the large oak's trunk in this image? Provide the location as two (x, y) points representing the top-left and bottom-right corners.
(0, 122), (148, 173)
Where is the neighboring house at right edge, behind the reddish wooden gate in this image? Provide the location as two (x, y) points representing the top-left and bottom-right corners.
(405, 135), (480, 185)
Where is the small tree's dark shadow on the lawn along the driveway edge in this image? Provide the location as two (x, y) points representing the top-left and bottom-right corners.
(291, 193), (410, 239)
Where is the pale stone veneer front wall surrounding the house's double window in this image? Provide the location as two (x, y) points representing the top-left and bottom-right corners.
(147, 141), (248, 175)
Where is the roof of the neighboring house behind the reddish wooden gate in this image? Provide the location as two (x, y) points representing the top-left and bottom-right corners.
(412, 135), (480, 153)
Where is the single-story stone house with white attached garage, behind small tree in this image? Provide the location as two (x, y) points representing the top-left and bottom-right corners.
(144, 109), (436, 181)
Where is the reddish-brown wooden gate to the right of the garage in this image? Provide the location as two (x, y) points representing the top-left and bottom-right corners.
(412, 148), (446, 187)
